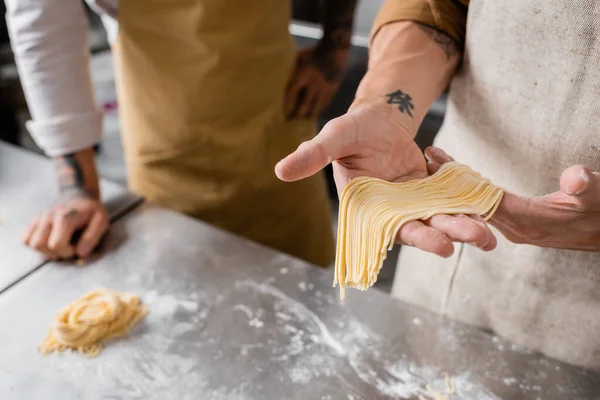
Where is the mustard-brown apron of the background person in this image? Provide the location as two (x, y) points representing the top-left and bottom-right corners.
(115, 0), (334, 266)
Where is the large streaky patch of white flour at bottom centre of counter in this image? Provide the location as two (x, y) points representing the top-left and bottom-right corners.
(236, 280), (500, 400)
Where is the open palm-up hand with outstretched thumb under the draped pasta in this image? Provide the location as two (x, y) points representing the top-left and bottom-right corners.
(275, 104), (496, 257)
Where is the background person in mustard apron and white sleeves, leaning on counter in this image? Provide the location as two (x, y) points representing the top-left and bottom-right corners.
(6, 0), (356, 266)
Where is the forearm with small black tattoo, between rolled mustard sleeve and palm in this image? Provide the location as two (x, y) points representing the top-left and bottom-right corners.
(351, 21), (461, 135)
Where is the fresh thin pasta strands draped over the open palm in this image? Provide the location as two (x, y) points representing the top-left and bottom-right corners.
(333, 162), (504, 299)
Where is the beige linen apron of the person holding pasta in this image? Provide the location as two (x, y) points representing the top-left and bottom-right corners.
(393, 0), (600, 368)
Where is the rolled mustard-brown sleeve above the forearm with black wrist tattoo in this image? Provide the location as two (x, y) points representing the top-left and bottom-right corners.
(371, 0), (469, 48)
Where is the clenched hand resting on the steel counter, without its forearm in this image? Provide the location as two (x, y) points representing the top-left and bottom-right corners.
(23, 196), (109, 259)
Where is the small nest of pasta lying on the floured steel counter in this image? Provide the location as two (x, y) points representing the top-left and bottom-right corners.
(39, 289), (148, 357)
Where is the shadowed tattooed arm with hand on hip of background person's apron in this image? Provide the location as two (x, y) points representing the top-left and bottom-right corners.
(285, 0), (356, 118)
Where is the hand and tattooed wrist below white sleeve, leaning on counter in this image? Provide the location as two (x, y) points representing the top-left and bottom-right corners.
(23, 149), (109, 259)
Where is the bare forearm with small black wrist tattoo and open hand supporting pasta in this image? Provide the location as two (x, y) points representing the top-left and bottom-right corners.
(275, 21), (496, 257)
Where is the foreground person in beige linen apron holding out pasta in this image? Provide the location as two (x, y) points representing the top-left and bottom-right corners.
(276, 0), (600, 368)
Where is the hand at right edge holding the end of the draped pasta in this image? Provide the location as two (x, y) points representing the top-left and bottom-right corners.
(432, 145), (600, 251)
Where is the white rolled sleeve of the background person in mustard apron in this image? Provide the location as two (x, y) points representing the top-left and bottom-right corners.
(5, 0), (102, 157)
